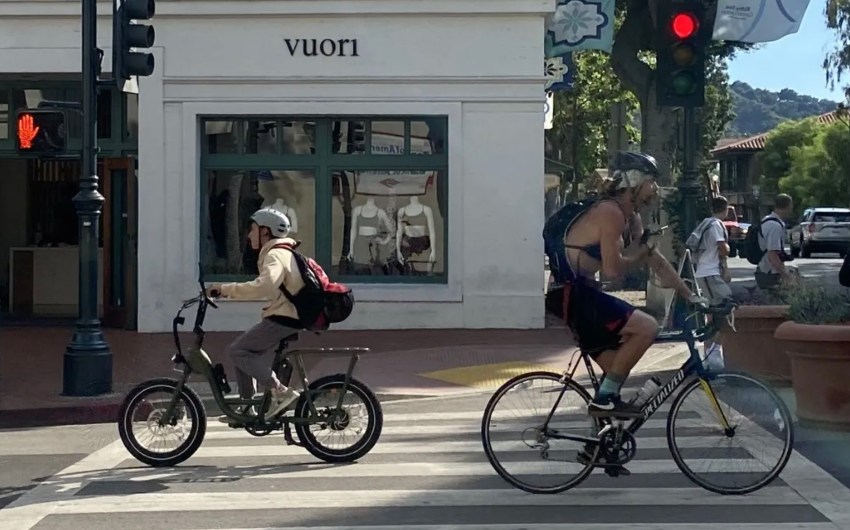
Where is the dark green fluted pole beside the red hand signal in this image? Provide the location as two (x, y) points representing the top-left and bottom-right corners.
(62, 0), (112, 396)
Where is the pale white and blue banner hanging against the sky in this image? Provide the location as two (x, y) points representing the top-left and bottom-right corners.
(712, 0), (810, 42)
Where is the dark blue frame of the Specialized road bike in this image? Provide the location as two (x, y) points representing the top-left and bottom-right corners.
(543, 300), (729, 444)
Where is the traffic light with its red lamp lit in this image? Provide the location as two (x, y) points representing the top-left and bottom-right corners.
(655, 0), (710, 107)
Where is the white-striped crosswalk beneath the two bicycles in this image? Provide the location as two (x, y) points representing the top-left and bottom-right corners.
(8, 380), (850, 530)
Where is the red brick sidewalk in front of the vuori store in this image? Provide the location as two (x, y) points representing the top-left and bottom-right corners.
(0, 327), (687, 428)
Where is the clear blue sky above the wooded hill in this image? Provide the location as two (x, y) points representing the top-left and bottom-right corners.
(729, 0), (850, 101)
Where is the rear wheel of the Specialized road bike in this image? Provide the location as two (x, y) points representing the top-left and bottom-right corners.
(481, 372), (600, 493)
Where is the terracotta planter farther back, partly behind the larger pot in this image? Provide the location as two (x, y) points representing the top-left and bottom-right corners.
(720, 305), (791, 385)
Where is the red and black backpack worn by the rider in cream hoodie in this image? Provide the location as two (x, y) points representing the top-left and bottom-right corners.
(272, 242), (354, 331)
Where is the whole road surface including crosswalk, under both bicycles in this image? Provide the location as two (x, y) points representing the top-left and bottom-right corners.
(0, 388), (850, 530)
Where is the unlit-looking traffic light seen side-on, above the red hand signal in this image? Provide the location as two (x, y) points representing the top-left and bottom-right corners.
(112, 0), (156, 90)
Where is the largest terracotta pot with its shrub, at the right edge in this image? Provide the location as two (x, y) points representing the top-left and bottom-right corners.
(775, 285), (850, 428)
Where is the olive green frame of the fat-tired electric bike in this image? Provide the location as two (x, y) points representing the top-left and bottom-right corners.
(159, 270), (369, 428)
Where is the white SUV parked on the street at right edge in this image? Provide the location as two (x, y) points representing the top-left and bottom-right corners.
(788, 208), (850, 258)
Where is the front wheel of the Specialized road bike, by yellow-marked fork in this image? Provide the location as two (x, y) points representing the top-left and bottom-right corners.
(667, 372), (794, 495)
